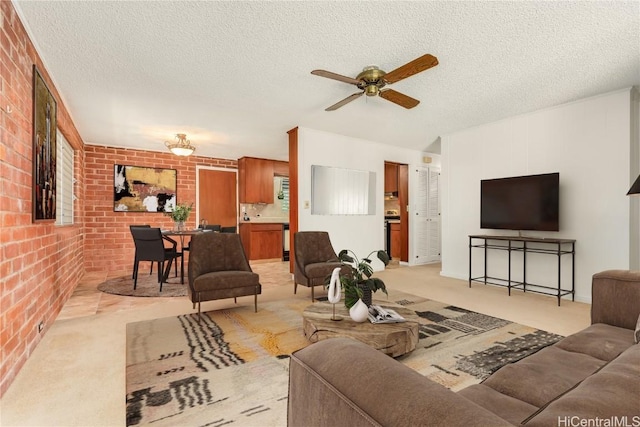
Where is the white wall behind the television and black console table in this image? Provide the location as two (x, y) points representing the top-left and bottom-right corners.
(441, 89), (639, 301)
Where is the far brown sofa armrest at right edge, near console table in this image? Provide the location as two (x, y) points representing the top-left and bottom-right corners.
(591, 270), (640, 330)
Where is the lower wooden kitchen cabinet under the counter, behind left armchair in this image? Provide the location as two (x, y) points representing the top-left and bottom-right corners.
(240, 222), (283, 261)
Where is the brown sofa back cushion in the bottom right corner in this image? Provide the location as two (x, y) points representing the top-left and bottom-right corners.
(525, 345), (640, 427)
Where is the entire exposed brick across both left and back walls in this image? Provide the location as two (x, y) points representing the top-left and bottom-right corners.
(0, 0), (237, 397)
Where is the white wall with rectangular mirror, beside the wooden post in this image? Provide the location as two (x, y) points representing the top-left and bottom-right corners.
(298, 127), (440, 270)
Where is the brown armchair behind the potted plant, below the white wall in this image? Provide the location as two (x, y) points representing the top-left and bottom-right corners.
(293, 231), (349, 301)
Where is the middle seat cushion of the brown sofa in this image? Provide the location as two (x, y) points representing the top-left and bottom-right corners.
(483, 345), (605, 408)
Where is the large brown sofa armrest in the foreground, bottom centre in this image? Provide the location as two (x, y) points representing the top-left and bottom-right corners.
(287, 338), (511, 427)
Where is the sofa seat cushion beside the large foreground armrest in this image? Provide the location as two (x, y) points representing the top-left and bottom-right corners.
(458, 384), (538, 425)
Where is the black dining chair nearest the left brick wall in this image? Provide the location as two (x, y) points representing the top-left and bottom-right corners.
(131, 227), (182, 292)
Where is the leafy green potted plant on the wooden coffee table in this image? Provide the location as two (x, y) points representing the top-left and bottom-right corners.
(325, 249), (389, 308)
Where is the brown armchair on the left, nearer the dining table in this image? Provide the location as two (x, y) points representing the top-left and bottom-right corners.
(189, 232), (262, 316)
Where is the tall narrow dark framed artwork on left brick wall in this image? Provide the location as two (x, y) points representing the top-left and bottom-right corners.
(33, 65), (57, 222)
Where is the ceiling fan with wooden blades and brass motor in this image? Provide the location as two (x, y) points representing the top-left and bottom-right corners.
(311, 53), (438, 111)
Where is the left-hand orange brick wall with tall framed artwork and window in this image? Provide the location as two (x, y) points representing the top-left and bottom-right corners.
(0, 0), (84, 397)
